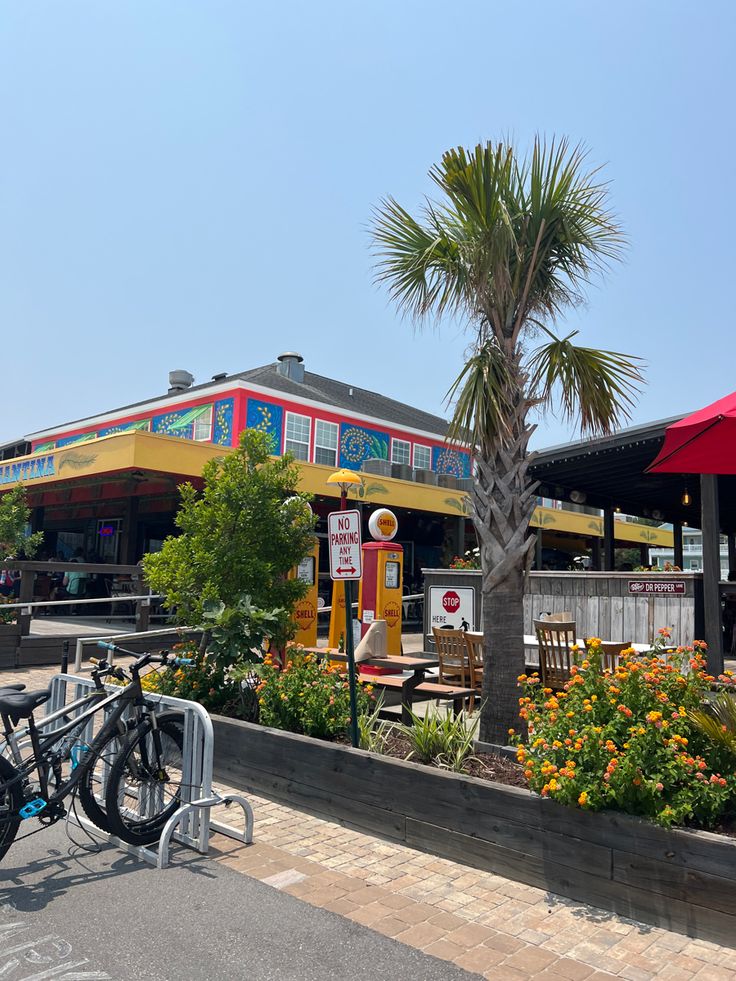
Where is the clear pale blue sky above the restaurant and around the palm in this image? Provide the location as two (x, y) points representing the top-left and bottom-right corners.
(0, 0), (736, 445)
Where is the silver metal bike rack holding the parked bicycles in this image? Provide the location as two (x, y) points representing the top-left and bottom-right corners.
(44, 674), (253, 869)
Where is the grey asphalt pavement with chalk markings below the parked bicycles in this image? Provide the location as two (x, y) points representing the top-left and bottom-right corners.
(0, 821), (478, 981)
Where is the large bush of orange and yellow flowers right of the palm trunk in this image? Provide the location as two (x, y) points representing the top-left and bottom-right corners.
(518, 631), (736, 828)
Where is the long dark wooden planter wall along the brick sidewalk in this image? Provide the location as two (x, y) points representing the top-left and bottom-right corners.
(213, 716), (736, 946)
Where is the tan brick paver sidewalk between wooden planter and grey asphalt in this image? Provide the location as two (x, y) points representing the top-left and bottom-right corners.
(0, 668), (736, 981)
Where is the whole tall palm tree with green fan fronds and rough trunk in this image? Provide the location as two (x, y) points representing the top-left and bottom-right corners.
(372, 138), (641, 742)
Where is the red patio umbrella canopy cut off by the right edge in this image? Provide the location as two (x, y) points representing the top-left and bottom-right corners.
(647, 392), (736, 474)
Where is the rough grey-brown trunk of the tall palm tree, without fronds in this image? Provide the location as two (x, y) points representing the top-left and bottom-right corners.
(473, 378), (536, 744)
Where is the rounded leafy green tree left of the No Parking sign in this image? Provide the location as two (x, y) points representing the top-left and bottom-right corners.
(143, 429), (314, 645)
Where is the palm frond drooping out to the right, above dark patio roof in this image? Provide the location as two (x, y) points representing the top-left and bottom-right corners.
(527, 328), (643, 435)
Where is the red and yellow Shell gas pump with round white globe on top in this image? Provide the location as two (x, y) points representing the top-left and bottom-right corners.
(358, 508), (404, 654)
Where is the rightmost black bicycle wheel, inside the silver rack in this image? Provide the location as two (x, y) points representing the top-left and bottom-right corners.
(105, 719), (184, 845)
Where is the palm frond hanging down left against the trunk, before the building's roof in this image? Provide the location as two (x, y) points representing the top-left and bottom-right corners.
(446, 338), (510, 447)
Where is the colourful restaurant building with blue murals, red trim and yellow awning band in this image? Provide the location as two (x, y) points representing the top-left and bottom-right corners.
(0, 353), (671, 593)
